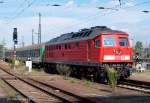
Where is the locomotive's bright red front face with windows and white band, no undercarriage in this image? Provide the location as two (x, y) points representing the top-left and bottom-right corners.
(101, 35), (132, 63)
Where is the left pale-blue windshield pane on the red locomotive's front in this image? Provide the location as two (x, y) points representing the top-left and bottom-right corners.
(104, 37), (116, 46)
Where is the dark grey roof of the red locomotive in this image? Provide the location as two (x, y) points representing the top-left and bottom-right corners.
(46, 26), (127, 45)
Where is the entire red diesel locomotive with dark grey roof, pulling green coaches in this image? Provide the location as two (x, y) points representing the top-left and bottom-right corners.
(44, 26), (132, 80)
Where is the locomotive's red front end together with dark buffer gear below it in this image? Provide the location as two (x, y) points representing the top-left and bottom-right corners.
(100, 34), (132, 78)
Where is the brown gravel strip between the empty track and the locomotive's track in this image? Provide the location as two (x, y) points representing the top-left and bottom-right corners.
(0, 60), (150, 103)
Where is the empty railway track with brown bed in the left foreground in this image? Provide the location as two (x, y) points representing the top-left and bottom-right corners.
(0, 68), (93, 103)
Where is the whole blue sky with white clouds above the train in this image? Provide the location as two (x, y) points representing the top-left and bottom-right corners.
(0, 0), (150, 47)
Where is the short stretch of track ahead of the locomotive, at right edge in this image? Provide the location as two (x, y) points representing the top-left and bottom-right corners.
(117, 79), (150, 94)
